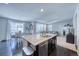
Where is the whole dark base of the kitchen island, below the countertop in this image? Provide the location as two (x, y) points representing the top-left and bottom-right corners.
(34, 37), (56, 56)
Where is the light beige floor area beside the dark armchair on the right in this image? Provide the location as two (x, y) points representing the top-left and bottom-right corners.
(57, 36), (77, 52)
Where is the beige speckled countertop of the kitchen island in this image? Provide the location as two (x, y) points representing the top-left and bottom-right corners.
(23, 34), (57, 46)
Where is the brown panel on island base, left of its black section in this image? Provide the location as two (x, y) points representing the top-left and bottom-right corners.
(39, 42), (48, 56)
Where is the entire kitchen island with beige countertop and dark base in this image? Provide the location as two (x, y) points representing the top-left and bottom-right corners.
(23, 33), (57, 56)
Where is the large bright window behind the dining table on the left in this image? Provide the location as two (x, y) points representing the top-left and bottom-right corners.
(9, 21), (24, 34)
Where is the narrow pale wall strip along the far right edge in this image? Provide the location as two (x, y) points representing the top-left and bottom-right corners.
(73, 4), (79, 55)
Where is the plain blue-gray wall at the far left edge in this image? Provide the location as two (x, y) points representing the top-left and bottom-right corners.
(0, 18), (7, 41)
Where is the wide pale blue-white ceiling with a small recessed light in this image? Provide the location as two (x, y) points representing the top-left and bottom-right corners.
(0, 3), (76, 23)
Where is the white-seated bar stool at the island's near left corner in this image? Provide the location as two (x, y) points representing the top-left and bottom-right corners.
(22, 46), (34, 56)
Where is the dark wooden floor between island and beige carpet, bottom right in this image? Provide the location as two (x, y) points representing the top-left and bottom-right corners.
(50, 46), (77, 56)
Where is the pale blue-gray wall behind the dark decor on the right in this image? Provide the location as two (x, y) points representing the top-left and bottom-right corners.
(52, 20), (73, 35)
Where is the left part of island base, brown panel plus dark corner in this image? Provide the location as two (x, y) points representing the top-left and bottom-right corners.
(34, 41), (48, 56)
